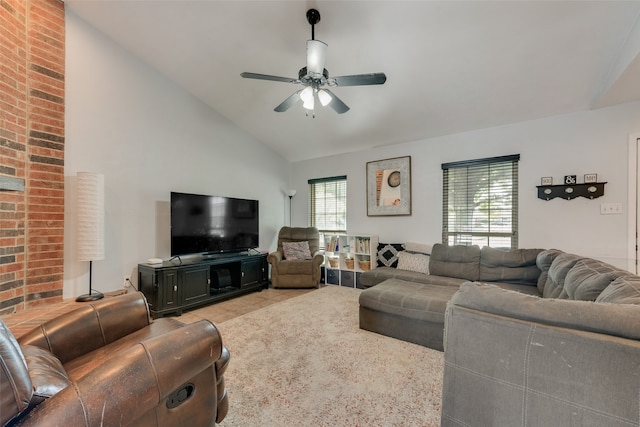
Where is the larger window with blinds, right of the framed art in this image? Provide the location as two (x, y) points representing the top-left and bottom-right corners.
(442, 154), (520, 249)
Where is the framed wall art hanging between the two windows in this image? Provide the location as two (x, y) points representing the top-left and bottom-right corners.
(367, 156), (411, 216)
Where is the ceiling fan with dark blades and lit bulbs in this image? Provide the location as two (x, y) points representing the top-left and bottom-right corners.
(240, 9), (387, 117)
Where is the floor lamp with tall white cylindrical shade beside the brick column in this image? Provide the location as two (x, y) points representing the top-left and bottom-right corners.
(76, 172), (104, 302)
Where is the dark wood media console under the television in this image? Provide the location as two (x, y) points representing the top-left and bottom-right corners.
(138, 253), (269, 318)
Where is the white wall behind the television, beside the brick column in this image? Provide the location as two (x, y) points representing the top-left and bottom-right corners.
(63, 12), (290, 298)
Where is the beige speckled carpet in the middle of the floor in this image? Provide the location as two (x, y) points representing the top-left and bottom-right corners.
(218, 286), (444, 427)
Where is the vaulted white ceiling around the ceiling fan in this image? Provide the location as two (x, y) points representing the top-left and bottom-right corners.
(65, 0), (640, 161)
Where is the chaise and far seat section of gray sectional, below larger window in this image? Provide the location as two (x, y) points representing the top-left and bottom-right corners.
(359, 244), (542, 350)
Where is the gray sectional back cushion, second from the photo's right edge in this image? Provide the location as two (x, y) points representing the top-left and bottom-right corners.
(564, 258), (619, 301)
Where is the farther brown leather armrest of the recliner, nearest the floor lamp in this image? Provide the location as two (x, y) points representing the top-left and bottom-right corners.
(18, 292), (151, 364)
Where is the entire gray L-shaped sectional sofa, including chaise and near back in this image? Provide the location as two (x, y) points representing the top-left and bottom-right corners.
(360, 245), (640, 426)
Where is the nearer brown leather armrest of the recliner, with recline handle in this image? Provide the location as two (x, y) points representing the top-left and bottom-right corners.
(21, 320), (222, 426)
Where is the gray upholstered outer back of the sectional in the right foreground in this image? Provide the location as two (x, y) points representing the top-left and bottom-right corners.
(442, 284), (640, 426)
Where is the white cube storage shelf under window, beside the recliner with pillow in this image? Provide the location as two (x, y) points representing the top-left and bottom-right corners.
(323, 234), (378, 288)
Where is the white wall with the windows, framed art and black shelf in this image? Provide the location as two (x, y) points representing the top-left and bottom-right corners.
(292, 103), (640, 268)
